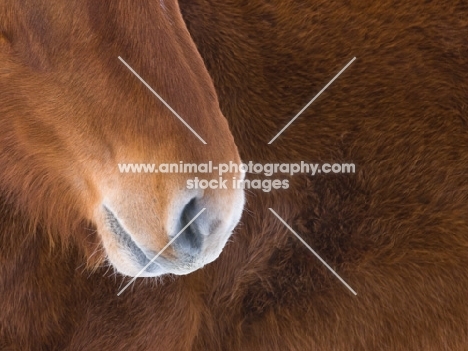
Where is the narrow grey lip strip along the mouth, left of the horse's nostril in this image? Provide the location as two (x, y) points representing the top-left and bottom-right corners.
(103, 205), (159, 273)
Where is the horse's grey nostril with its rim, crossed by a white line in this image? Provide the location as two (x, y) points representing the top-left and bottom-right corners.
(169, 198), (204, 256)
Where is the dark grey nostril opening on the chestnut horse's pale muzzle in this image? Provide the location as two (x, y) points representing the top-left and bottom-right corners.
(174, 198), (203, 255)
